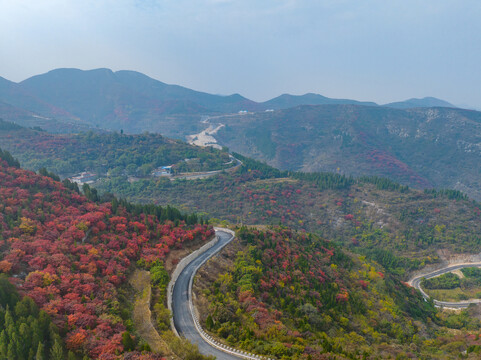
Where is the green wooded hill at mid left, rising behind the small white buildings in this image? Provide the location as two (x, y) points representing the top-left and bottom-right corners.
(0, 119), (232, 177)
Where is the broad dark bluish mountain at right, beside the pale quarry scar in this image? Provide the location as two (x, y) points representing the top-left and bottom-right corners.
(215, 105), (481, 200)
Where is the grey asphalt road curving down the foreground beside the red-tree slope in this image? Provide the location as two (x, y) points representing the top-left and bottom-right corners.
(172, 230), (239, 360)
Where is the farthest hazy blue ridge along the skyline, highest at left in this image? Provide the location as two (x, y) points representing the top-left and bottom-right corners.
(0, 68), (453, 133)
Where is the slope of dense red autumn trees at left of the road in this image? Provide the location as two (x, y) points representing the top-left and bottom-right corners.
(0, 153), (214, 359)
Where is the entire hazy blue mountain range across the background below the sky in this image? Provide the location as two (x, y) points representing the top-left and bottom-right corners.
(0, 69), (481, 199)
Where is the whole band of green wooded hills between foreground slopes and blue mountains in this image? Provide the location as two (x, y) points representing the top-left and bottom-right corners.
(0, 122), (481, 273)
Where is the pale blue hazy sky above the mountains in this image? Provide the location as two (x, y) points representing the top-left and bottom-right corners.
(0, 0), (481, 108)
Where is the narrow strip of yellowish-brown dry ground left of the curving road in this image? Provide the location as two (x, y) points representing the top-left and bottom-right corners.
(129, 269), (170, 355)
